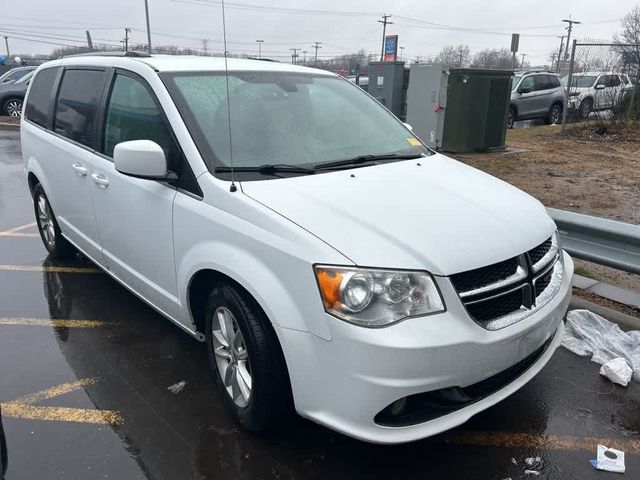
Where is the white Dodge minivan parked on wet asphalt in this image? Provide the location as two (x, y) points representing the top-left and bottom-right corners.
(21, 53), (573, 443)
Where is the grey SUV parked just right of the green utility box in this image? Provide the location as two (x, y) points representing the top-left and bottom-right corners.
(507, 71), (566, 128)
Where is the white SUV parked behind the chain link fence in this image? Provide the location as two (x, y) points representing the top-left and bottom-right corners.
(564, 72), (633, 118)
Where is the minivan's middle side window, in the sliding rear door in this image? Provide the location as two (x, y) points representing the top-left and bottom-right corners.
(54, 70), (107, 148)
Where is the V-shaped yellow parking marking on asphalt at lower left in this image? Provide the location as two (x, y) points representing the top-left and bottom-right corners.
(0, 378), (123, 425)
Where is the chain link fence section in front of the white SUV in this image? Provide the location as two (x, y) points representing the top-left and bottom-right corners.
(561, 41), (640, 135)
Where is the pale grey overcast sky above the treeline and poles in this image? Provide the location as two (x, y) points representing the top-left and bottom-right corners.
(0, 0), (638, 65)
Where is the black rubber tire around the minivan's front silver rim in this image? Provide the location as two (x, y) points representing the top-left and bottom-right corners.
(205, 282), (292, 433)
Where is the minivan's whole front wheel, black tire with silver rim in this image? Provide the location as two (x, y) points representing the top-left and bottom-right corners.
(206, 283), (291, 432)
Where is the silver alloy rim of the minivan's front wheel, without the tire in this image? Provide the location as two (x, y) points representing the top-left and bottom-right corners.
(211, 307), (252, 408)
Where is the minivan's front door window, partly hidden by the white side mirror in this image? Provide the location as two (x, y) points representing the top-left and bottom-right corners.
(103, 75), (181, 172)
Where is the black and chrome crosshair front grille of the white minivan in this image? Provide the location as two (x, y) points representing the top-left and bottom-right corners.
(450, 238), (562, 330)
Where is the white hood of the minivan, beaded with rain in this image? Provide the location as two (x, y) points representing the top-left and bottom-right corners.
(241, 154), (555, 275)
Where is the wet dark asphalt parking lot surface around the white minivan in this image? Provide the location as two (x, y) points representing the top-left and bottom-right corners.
(0, 130), (640, 480)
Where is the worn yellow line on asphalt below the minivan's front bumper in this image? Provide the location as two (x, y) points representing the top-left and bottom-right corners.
(447, 431), (640, 455)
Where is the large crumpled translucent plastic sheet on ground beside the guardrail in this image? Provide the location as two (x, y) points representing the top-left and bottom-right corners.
(562, 310), (640, 380)
